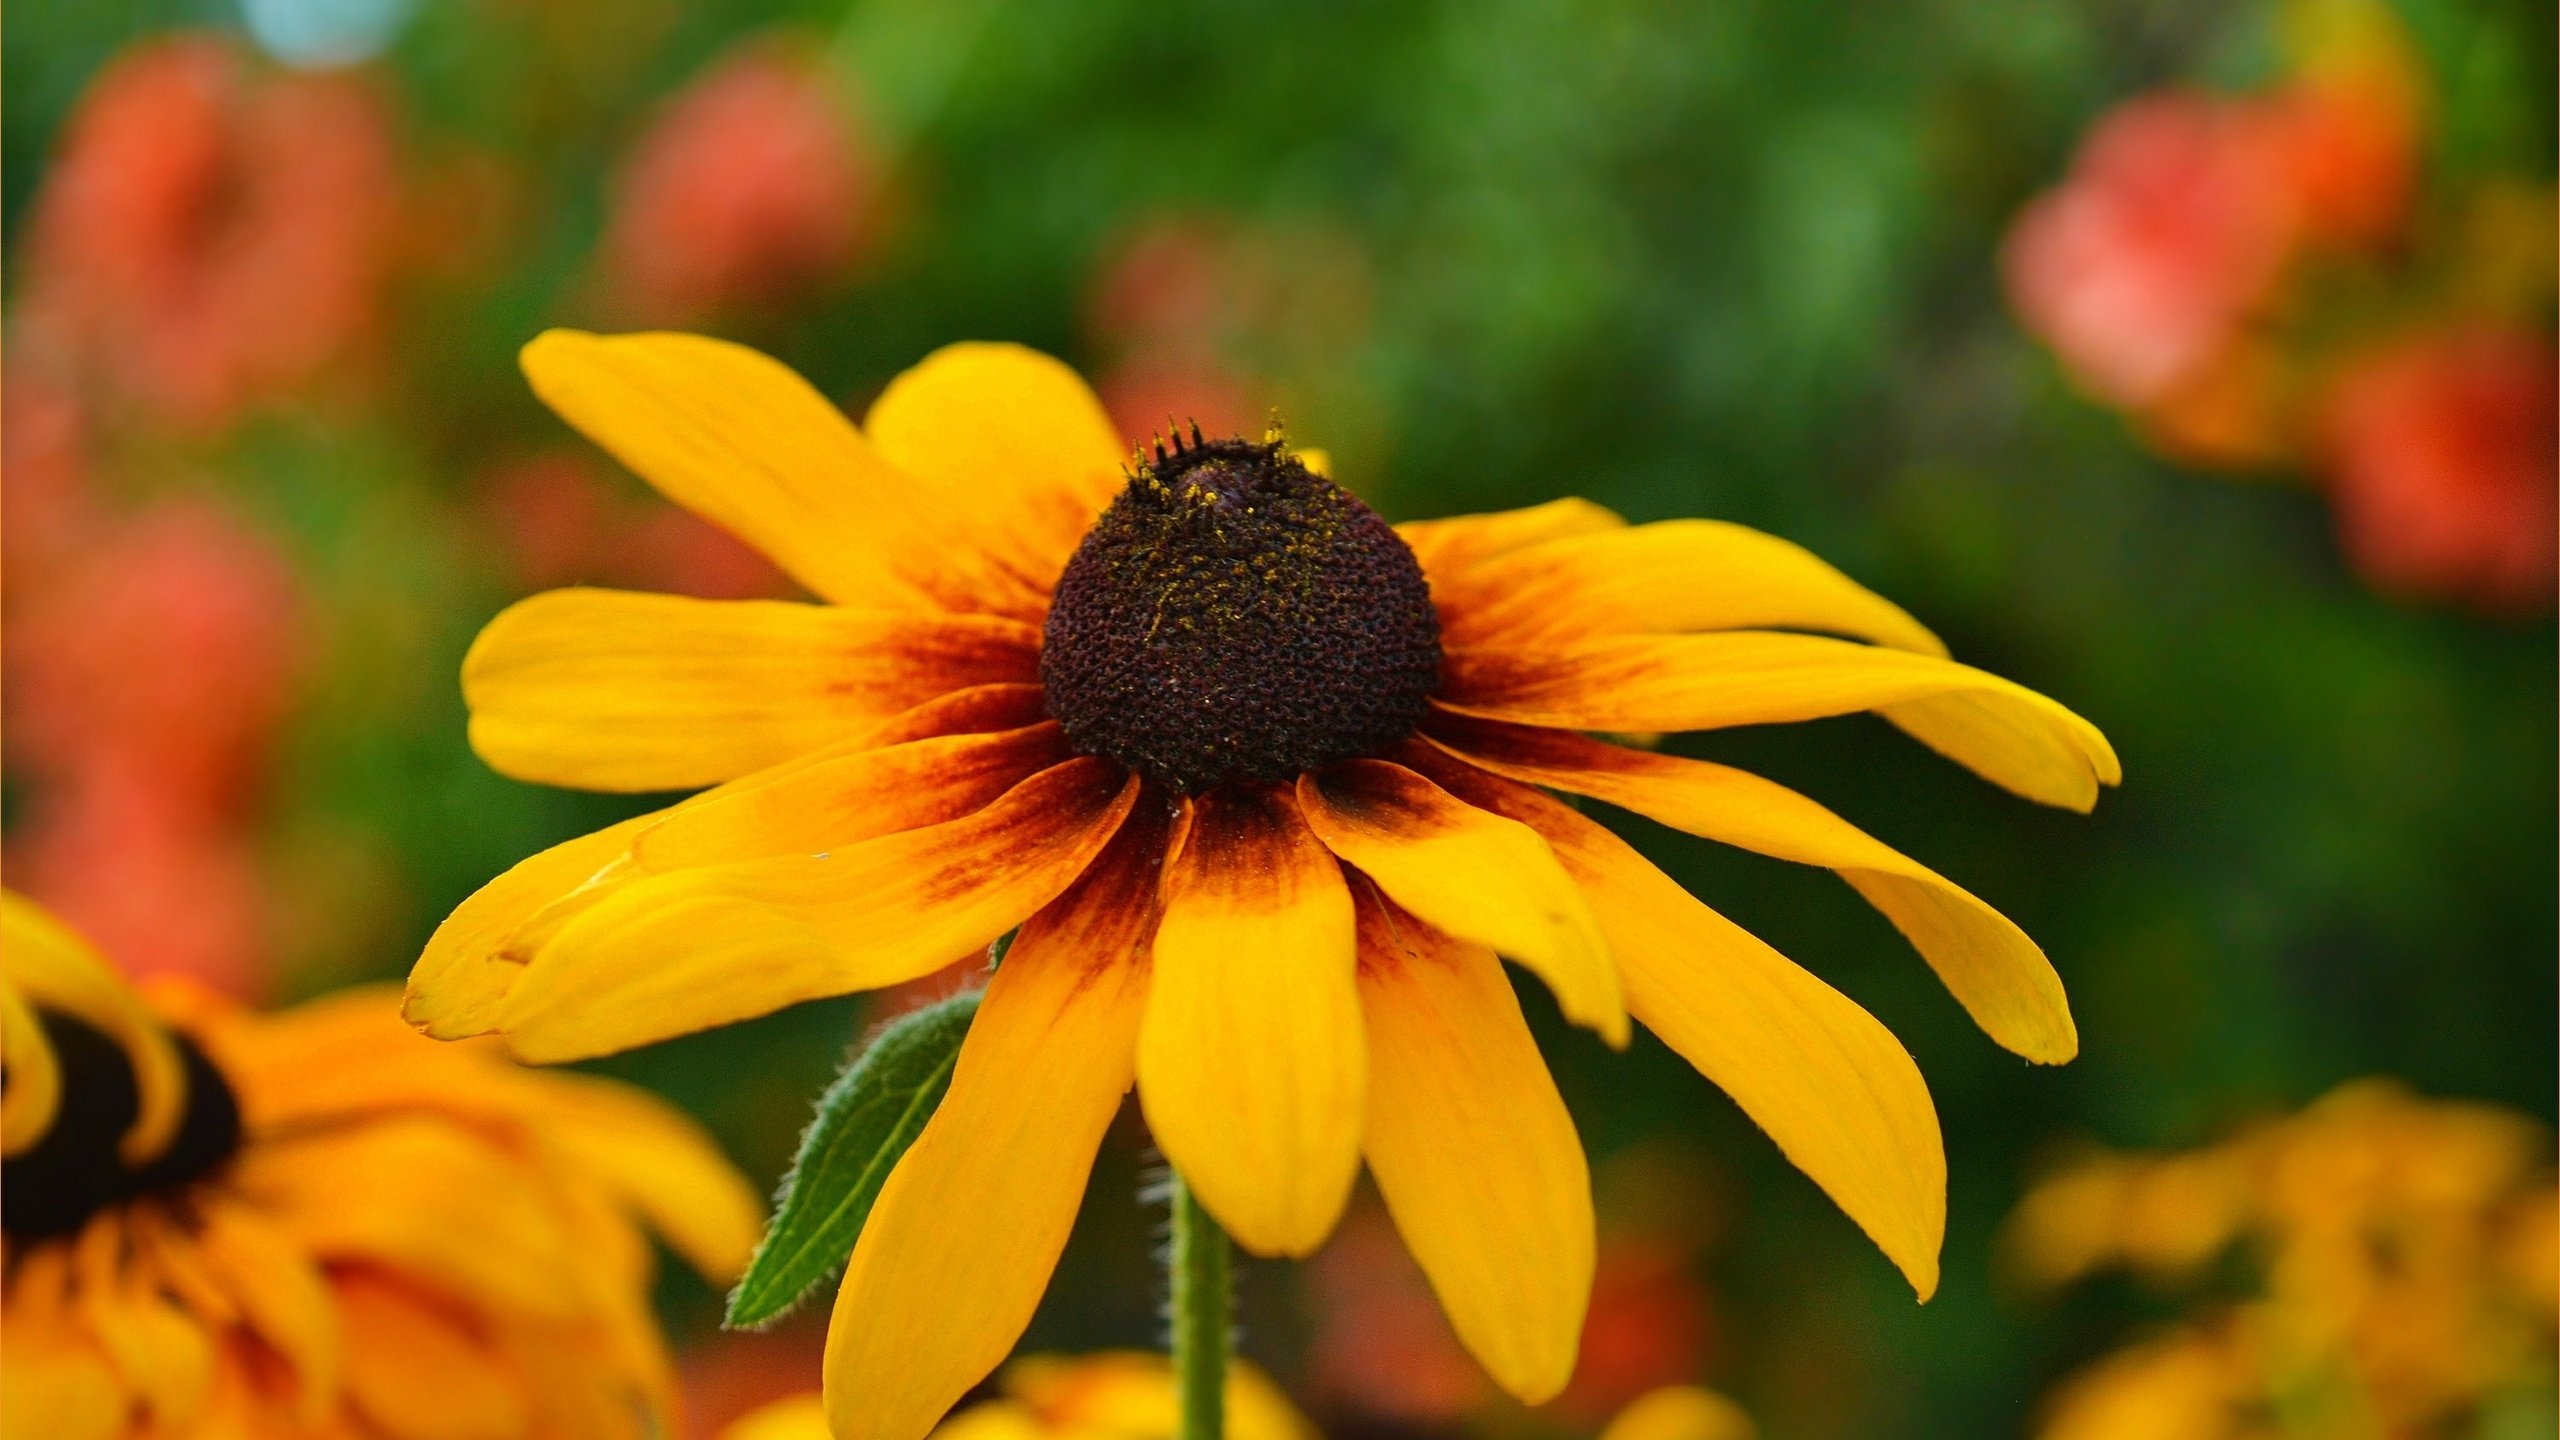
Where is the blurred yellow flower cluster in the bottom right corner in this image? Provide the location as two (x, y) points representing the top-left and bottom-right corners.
(2004, 1081), (2560, 1440)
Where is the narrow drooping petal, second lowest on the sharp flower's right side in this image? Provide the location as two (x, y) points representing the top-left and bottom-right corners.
(1434, 720), (2079, 1066)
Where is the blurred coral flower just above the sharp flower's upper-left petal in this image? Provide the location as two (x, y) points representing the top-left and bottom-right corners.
(602, 36), (881, 323)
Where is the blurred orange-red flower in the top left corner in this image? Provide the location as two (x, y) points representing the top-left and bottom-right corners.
(18, 33), (399, 430)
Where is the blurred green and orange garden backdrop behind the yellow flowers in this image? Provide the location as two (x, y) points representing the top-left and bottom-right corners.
(0, 0), (2560, 1437)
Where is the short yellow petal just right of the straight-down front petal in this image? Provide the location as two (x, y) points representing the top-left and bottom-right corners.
(1298, 761), (1628, 1045)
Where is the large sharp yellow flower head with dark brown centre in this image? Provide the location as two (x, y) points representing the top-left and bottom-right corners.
(407, 331), (2117, 1440)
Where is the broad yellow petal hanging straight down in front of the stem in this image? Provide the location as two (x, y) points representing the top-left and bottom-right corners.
(1137, 787), (1367, 1256)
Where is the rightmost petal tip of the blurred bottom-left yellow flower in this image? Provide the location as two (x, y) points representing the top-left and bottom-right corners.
(519, 1074), (765, 1284)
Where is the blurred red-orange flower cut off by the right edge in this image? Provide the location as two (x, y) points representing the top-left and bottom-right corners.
(2322, 331), (2560, 612)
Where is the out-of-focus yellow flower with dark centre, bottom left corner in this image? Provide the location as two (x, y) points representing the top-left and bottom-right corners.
(0, 894), (758, 1440)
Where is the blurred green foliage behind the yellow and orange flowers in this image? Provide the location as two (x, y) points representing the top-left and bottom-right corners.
(0, 0), (2560, 1437)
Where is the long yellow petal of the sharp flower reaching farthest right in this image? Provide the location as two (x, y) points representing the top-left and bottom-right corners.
(1441, 630), (2125, 810)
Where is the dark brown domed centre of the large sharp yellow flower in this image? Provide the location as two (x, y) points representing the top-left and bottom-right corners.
(1039, 436), (1441, 794)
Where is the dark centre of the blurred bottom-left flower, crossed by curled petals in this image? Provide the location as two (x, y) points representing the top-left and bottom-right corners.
(0, 1007), (241, 1243)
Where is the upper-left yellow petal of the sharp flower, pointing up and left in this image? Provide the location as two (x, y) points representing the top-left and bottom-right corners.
(522, 331), (1009, 612)
